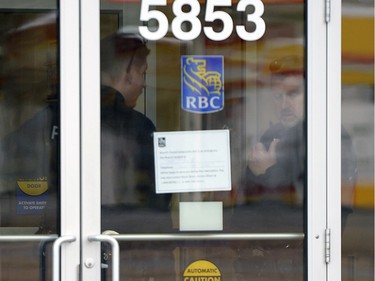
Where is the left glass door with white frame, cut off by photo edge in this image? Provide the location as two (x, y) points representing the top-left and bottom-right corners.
(0, 0), (80, 280)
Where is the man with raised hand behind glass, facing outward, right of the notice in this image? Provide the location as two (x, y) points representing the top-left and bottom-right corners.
(244, 55), (305, 232)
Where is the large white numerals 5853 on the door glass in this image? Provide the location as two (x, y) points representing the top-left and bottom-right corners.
(139, 0), (266, 41)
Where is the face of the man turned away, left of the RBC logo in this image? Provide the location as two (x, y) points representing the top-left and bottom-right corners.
(124, 63), (147, 108)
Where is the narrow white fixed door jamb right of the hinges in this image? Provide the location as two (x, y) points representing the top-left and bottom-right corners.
(327, 1), (341, 280)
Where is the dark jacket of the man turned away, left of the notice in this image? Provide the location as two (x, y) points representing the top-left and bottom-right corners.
(101, 87), (159, 206)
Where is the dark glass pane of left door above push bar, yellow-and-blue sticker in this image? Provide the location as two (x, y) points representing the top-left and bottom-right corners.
(0, 10), (59, 234)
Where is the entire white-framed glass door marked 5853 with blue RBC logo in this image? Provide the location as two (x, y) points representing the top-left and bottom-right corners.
(81, 0), (326, 280)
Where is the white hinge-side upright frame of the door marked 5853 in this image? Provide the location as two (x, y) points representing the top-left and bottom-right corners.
(307, 0), (327, 281)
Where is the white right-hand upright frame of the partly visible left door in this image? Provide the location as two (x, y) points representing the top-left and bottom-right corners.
(59, 0), (80, 281)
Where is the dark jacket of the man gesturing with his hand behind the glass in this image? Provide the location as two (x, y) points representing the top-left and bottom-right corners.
(245, 123), (305, 204)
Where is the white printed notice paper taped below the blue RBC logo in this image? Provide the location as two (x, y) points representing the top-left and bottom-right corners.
(154, 130), (231, 193)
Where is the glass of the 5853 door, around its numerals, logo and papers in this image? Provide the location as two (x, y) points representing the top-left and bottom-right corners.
(101, 1), (306, 280)
